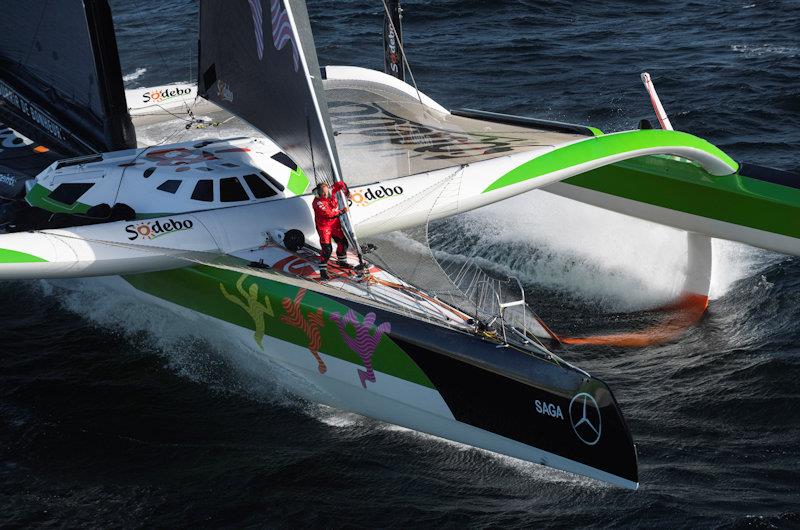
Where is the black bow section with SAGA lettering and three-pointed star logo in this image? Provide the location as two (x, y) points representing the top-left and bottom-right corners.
(342, 294), (639, 487)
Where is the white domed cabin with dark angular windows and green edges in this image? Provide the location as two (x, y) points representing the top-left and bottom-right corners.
(26, 138), (310, 219)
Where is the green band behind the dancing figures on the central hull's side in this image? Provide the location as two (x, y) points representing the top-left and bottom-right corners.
(123, 265), (435, 388)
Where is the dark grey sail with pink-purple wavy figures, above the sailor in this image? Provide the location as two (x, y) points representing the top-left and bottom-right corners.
(198, 0), (340, 188)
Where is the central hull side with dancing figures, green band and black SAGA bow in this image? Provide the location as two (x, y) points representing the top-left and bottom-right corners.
(111, 266), (638, 488)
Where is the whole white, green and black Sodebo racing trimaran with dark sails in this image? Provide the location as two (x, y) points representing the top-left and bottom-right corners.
(0, 0), (800, 488)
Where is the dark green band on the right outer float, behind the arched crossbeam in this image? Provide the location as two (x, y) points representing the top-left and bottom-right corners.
(564, 156), (800, 238)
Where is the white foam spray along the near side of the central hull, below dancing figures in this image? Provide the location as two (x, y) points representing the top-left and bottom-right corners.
(39, 278), (321, 410)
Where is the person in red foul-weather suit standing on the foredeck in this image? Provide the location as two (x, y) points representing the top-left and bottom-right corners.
(312, 181), (351, 280)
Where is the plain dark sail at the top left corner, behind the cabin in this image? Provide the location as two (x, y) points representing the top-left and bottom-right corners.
(0, 0), (136, 154)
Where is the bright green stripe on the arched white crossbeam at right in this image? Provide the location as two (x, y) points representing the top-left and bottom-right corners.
(483, 129), (739, 193)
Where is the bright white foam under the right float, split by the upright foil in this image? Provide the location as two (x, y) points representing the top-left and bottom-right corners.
(454, 191), (779, 311)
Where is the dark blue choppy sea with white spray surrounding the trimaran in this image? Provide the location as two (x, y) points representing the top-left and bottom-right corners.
(0, 0), (800, 528)
